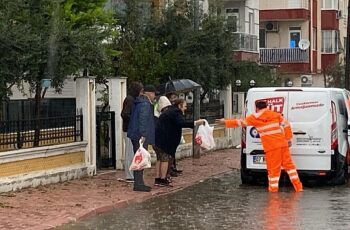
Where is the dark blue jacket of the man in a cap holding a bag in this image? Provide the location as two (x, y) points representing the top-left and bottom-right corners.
(128, 96), (155, 145)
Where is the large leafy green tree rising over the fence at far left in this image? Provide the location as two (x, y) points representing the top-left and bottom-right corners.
(0, 0), (118, 146)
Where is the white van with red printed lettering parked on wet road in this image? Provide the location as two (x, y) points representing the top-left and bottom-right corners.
(241, 87), (350, 184)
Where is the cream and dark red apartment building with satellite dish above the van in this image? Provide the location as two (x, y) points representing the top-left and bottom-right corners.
(259, 0), (347, 86)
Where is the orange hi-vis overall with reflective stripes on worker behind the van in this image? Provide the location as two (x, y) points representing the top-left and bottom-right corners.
(225, 109), (303, 192)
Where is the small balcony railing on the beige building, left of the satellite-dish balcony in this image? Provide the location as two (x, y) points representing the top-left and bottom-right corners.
(233, 33), (258, 52)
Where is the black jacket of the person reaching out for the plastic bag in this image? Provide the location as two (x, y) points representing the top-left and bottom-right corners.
(156, 106), (194, 156)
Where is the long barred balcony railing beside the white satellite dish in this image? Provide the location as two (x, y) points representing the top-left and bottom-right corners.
(260, 48), (309, 64)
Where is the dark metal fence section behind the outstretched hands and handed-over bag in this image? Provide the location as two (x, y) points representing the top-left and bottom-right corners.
(185, 101), (225, 123)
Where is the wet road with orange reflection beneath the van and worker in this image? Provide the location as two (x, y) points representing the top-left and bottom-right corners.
(58, 172), (350, 230)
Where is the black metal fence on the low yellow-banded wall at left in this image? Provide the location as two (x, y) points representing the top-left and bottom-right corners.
(0, 115), (83, 152)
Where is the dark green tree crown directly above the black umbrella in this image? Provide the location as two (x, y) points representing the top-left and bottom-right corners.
(177, 7), (234, 98)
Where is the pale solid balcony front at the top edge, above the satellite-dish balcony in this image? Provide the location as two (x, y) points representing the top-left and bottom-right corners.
(260, 0), (309, 10)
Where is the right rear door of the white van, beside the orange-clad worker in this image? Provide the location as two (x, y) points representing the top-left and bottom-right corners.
(287, 91), (330, 170)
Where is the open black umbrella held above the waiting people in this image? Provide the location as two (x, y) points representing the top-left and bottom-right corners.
(158, 79), (201, 94)
